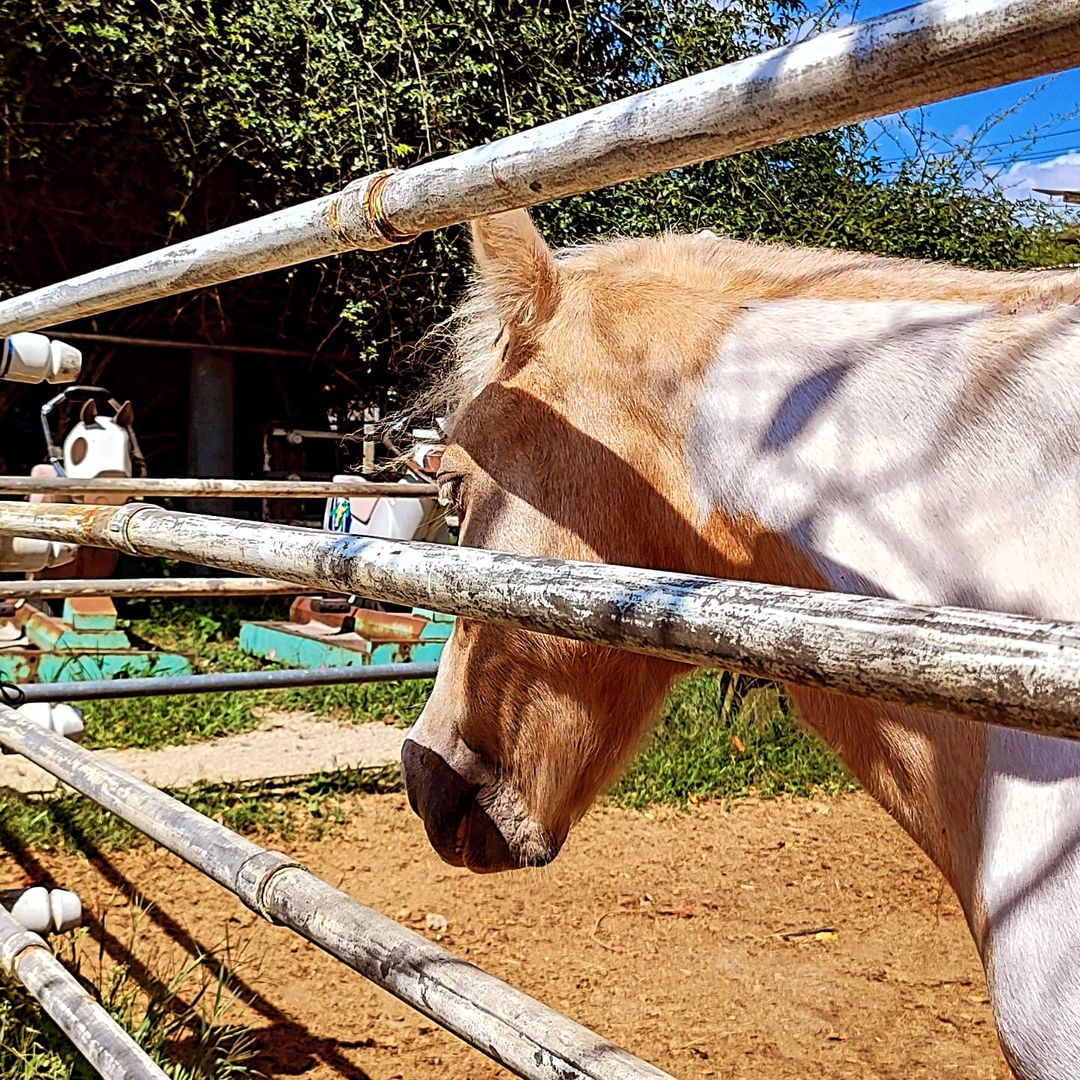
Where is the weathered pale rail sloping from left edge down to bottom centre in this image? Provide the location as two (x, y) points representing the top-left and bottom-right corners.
(0, 705), (671, 1080)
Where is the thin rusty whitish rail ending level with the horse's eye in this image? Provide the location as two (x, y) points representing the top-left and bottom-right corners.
(0, 479), (438, 499)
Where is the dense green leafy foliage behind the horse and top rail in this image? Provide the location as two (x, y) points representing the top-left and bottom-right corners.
(0, 0), (1052, 470)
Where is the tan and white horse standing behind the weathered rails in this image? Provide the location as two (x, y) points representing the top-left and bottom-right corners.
(403, 212), (1080, 1080)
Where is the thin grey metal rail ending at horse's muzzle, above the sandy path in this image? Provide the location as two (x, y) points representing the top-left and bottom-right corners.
(17, 661), (438, 702)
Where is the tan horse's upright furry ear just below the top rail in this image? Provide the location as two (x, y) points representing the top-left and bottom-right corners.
(472, 210), (558, 327)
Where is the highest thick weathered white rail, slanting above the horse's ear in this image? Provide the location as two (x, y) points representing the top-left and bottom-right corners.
(0, 0), (1080, 335)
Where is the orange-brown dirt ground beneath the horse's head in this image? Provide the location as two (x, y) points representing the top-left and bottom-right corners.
(0, 795), (1008, 1080)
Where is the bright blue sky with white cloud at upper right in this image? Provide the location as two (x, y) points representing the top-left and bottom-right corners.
(820, 0), (1080, 202)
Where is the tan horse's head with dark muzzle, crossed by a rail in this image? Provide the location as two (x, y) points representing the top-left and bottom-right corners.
(402, 212), (734, 872)
